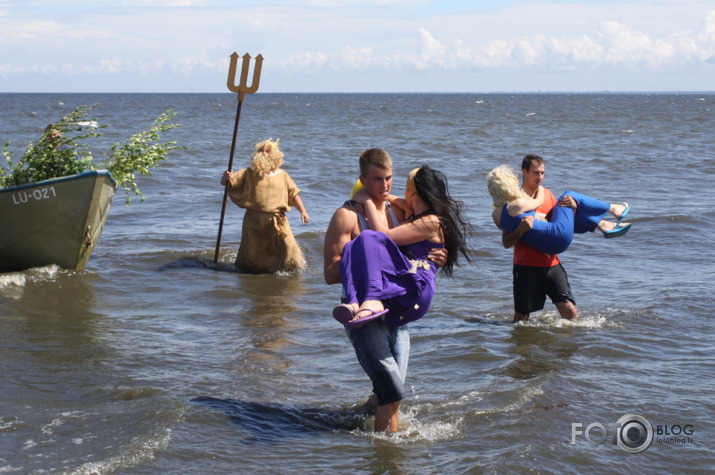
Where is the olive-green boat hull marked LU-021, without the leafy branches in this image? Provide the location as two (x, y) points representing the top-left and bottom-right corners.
(0, 170), (117, 272)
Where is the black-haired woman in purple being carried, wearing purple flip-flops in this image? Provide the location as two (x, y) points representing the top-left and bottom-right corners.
(333, 165), (471, 328)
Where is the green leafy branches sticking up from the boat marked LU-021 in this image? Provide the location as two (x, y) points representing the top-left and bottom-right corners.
(0, 104), (186, 205)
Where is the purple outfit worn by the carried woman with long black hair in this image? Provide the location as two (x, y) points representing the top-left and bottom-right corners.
(340, 230), (444, 327)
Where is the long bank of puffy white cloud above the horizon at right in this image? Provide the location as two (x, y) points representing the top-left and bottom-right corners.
(282, 11), (715, 72)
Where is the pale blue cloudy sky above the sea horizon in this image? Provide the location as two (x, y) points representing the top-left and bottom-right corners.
(0, 0), (715, 93)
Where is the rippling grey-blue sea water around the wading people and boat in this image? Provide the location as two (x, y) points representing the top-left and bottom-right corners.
(0, 94), (715, 473)
